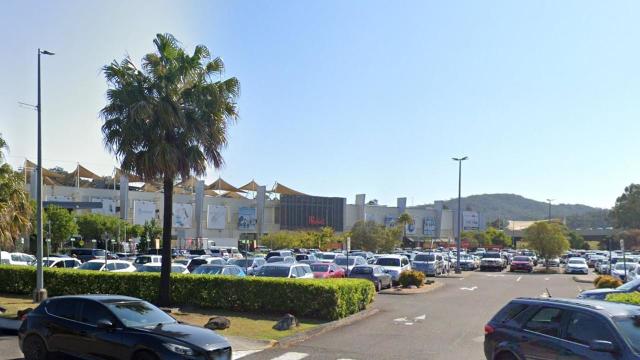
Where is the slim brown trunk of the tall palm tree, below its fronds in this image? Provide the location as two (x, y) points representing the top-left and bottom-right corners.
(160, 175), (173, 306)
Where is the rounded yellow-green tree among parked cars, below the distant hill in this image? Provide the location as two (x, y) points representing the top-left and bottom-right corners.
(524, 222), (569, 268)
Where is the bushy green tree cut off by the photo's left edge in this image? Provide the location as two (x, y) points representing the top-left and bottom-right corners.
(0, 163), (34, 249)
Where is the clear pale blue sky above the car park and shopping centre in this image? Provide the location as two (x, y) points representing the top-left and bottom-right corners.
(0, 0), (640, 207)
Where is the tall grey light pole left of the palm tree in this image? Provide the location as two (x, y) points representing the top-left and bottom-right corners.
(33, 48), (54, 302)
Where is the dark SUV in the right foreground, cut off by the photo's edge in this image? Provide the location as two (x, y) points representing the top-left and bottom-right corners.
(484, 298), (640, 360)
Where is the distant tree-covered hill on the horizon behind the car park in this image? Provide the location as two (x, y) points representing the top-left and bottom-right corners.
(424, 194), (609, 228)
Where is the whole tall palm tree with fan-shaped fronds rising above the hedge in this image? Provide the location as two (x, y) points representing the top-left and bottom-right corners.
(101, 34), (240, 306)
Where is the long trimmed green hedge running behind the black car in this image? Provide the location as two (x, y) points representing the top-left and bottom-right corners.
(0, 265), (375, 320)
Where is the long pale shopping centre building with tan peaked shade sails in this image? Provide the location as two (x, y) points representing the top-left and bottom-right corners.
(25, 165), (484, 248)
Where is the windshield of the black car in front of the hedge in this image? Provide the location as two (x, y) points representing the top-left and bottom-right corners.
(105, 301), (176, 327)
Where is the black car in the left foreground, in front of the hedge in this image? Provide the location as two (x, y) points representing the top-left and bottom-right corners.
(18, 295), (231, 360)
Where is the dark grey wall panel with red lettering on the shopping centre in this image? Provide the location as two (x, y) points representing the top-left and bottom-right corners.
(280, 195), (346, 231)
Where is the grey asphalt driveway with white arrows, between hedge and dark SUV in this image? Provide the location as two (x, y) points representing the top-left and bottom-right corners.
(0, 272), (589, 360)
